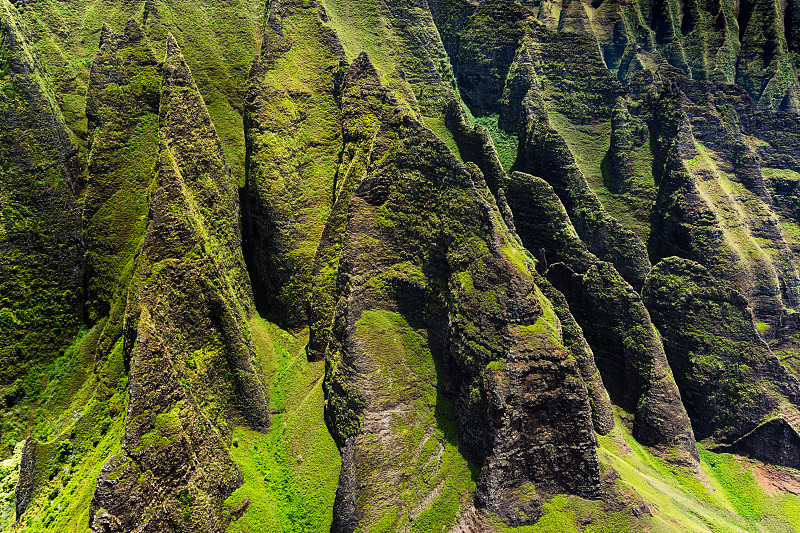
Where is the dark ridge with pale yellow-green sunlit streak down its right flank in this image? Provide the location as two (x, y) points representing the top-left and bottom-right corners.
(651, 69), (799, 339)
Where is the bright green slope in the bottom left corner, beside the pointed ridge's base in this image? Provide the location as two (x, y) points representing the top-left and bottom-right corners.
(0, 323), (128, 532)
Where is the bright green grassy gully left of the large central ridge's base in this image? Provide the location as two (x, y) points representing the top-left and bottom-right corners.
(225, 317), (341, 533)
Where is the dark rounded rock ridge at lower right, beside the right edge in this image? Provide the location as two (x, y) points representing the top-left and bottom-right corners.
(643, 257), (800, 466)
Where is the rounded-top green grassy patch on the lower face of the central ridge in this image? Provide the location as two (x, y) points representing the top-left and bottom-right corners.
(356, 310), (477, 533)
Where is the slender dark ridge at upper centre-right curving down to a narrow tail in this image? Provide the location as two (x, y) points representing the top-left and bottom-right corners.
(501, 28), (650, 287)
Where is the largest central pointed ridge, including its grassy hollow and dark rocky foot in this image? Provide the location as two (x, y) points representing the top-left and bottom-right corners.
(318, 55), (599, 531)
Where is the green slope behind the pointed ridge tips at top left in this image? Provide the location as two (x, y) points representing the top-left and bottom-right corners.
(12, 0), (260, 183)
